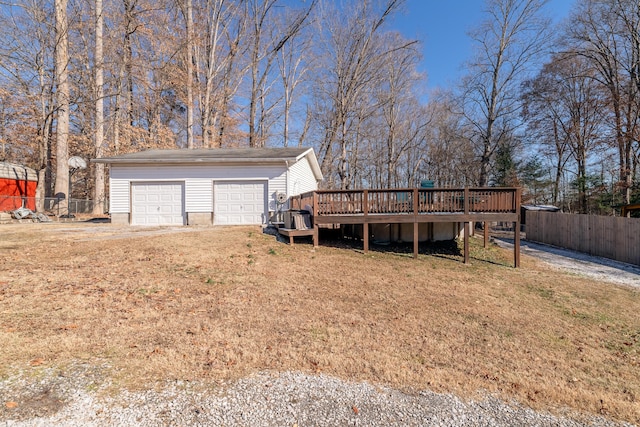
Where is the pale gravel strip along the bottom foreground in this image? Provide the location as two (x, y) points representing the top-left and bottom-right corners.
(0, 366), (631, 427)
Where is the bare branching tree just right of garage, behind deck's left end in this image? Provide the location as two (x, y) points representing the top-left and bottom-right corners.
(316, 0), (414, 189)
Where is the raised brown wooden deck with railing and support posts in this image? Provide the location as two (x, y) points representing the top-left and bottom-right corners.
(289, 187), (520, 267)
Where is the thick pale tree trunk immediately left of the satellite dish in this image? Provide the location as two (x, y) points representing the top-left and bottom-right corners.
(55, 0), (71, 213)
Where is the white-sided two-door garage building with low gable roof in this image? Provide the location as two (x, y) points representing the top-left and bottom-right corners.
(93, 148), (322, 225)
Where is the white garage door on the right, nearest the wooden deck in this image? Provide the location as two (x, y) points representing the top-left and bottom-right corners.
(213, 181), (267, 225)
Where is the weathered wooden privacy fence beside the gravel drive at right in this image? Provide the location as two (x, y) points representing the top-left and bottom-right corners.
(526, 211), (640, 265)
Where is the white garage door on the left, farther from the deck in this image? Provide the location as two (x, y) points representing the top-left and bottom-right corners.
(131, 182), (184, 225)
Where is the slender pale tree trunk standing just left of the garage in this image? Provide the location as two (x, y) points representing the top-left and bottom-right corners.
(93, 0), (105, 214)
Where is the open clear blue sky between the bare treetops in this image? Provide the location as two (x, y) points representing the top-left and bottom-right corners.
(391, 0), (580, 88)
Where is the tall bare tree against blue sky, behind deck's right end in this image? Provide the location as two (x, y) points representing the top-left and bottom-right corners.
(462, 0), (549, 186)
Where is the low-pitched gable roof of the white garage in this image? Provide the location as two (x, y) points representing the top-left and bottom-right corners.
(91, 147), (322, 181)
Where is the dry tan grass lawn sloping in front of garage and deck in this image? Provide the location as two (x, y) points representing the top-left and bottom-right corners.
(0, 224), (640, 423)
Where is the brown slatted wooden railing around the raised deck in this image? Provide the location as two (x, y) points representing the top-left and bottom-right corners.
(290, 187), (518, 216)
